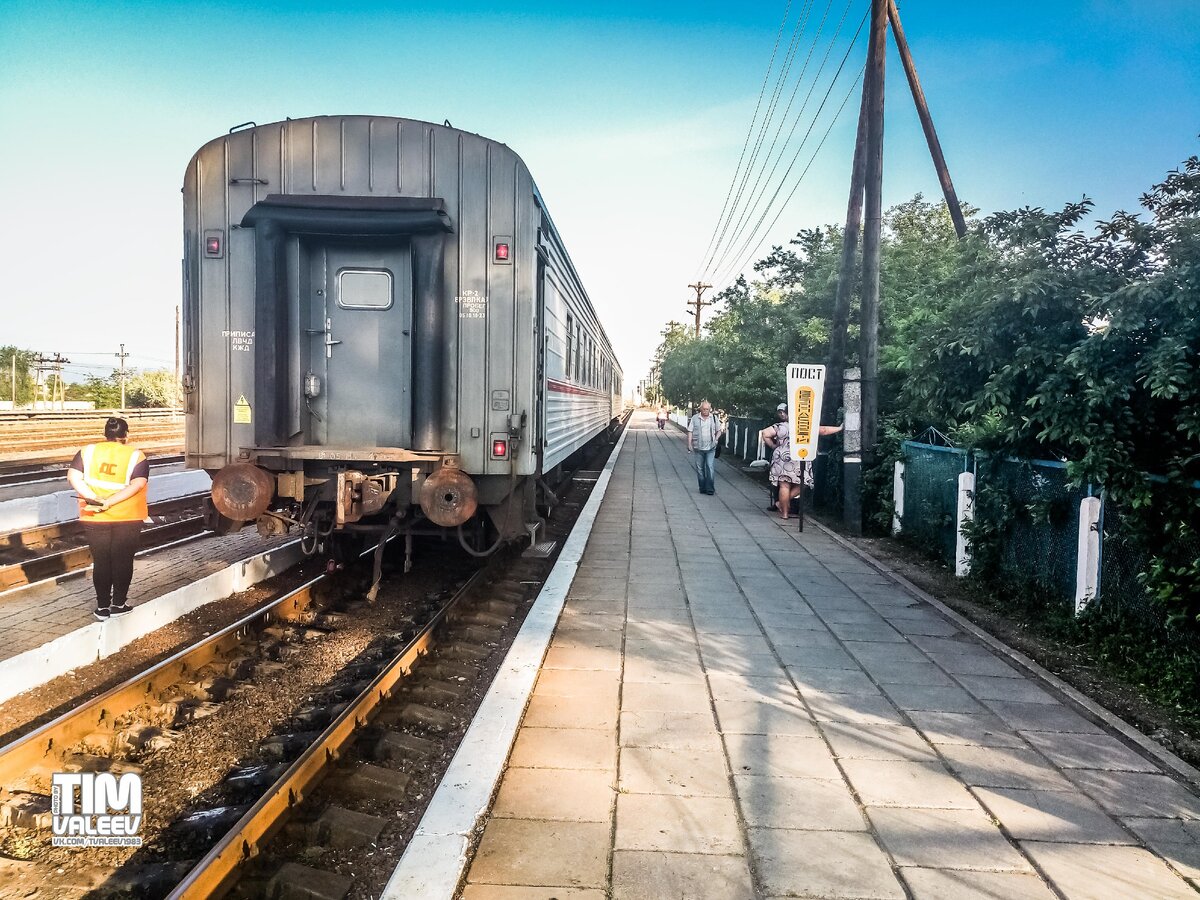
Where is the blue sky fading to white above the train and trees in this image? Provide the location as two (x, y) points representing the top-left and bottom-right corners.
(0, 0), (1200, 380)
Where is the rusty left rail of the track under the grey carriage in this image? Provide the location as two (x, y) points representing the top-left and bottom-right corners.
(0, 575), (329, 792)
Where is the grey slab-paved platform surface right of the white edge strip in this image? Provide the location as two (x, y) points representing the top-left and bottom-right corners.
(451, 413), (1200, 900)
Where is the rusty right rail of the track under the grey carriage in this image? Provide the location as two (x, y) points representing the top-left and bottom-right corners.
(168, 570), (486, 900)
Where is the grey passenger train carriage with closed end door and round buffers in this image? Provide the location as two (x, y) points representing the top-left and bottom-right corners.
(184, 116), (622, 561)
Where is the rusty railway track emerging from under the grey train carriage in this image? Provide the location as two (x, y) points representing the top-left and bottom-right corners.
(0, 542), (528, 898)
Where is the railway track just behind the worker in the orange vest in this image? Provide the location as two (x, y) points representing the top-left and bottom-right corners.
(0, 494), (205, 593)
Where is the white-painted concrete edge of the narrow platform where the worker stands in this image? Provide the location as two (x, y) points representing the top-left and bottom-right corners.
(0, 540), (304, 702)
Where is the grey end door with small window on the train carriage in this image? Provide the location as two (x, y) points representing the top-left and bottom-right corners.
(304, 241), (413, 448)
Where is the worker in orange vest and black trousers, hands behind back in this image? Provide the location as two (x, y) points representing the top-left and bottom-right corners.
(67, 416), (150, 622)
